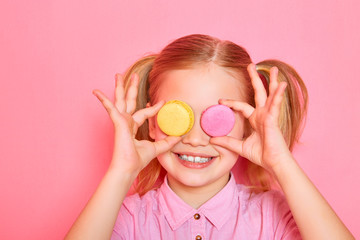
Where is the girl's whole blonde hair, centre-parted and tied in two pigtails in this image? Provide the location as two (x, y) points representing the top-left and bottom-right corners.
(120, 34), (308, 195)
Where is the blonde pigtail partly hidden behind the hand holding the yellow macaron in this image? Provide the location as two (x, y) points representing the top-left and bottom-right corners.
(124, 54), (162, 196)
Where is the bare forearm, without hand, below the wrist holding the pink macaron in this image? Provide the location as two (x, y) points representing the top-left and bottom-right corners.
(273, 155), (355, 239)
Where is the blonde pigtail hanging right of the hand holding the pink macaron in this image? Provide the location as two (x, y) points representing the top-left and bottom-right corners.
(256, 59), (308, 151)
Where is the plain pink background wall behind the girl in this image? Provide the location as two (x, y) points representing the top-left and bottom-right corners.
(0, 0), (360, 239)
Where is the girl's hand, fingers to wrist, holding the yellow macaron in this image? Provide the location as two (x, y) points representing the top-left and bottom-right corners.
(93, 74), (181, 175)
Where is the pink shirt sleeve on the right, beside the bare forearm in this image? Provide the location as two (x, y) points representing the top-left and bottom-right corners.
(266, 191), (302, 240)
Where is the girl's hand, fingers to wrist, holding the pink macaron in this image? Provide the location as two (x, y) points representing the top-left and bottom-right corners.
(210, 64), (291, 172)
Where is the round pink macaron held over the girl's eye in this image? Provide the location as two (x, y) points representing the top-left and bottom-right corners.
(200, 104), (235, 137)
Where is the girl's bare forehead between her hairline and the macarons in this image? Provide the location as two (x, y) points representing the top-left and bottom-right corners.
(156, 64), (245, 108)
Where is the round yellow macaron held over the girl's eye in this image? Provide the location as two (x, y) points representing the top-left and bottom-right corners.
(156, 100), (194, 136)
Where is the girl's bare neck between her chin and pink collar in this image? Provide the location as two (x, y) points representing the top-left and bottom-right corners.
(167, 174), (230, 209)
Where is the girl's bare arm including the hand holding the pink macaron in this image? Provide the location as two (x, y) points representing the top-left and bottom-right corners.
(210, 64), (354, 240)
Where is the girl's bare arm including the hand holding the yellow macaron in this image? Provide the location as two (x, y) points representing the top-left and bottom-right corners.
(66, 75), (181, 240)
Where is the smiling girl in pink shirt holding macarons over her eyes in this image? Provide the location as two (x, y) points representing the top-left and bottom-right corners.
(67, 34), (353, 239)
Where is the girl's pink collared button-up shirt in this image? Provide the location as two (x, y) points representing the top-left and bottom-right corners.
(111, 174), (301, 240)
